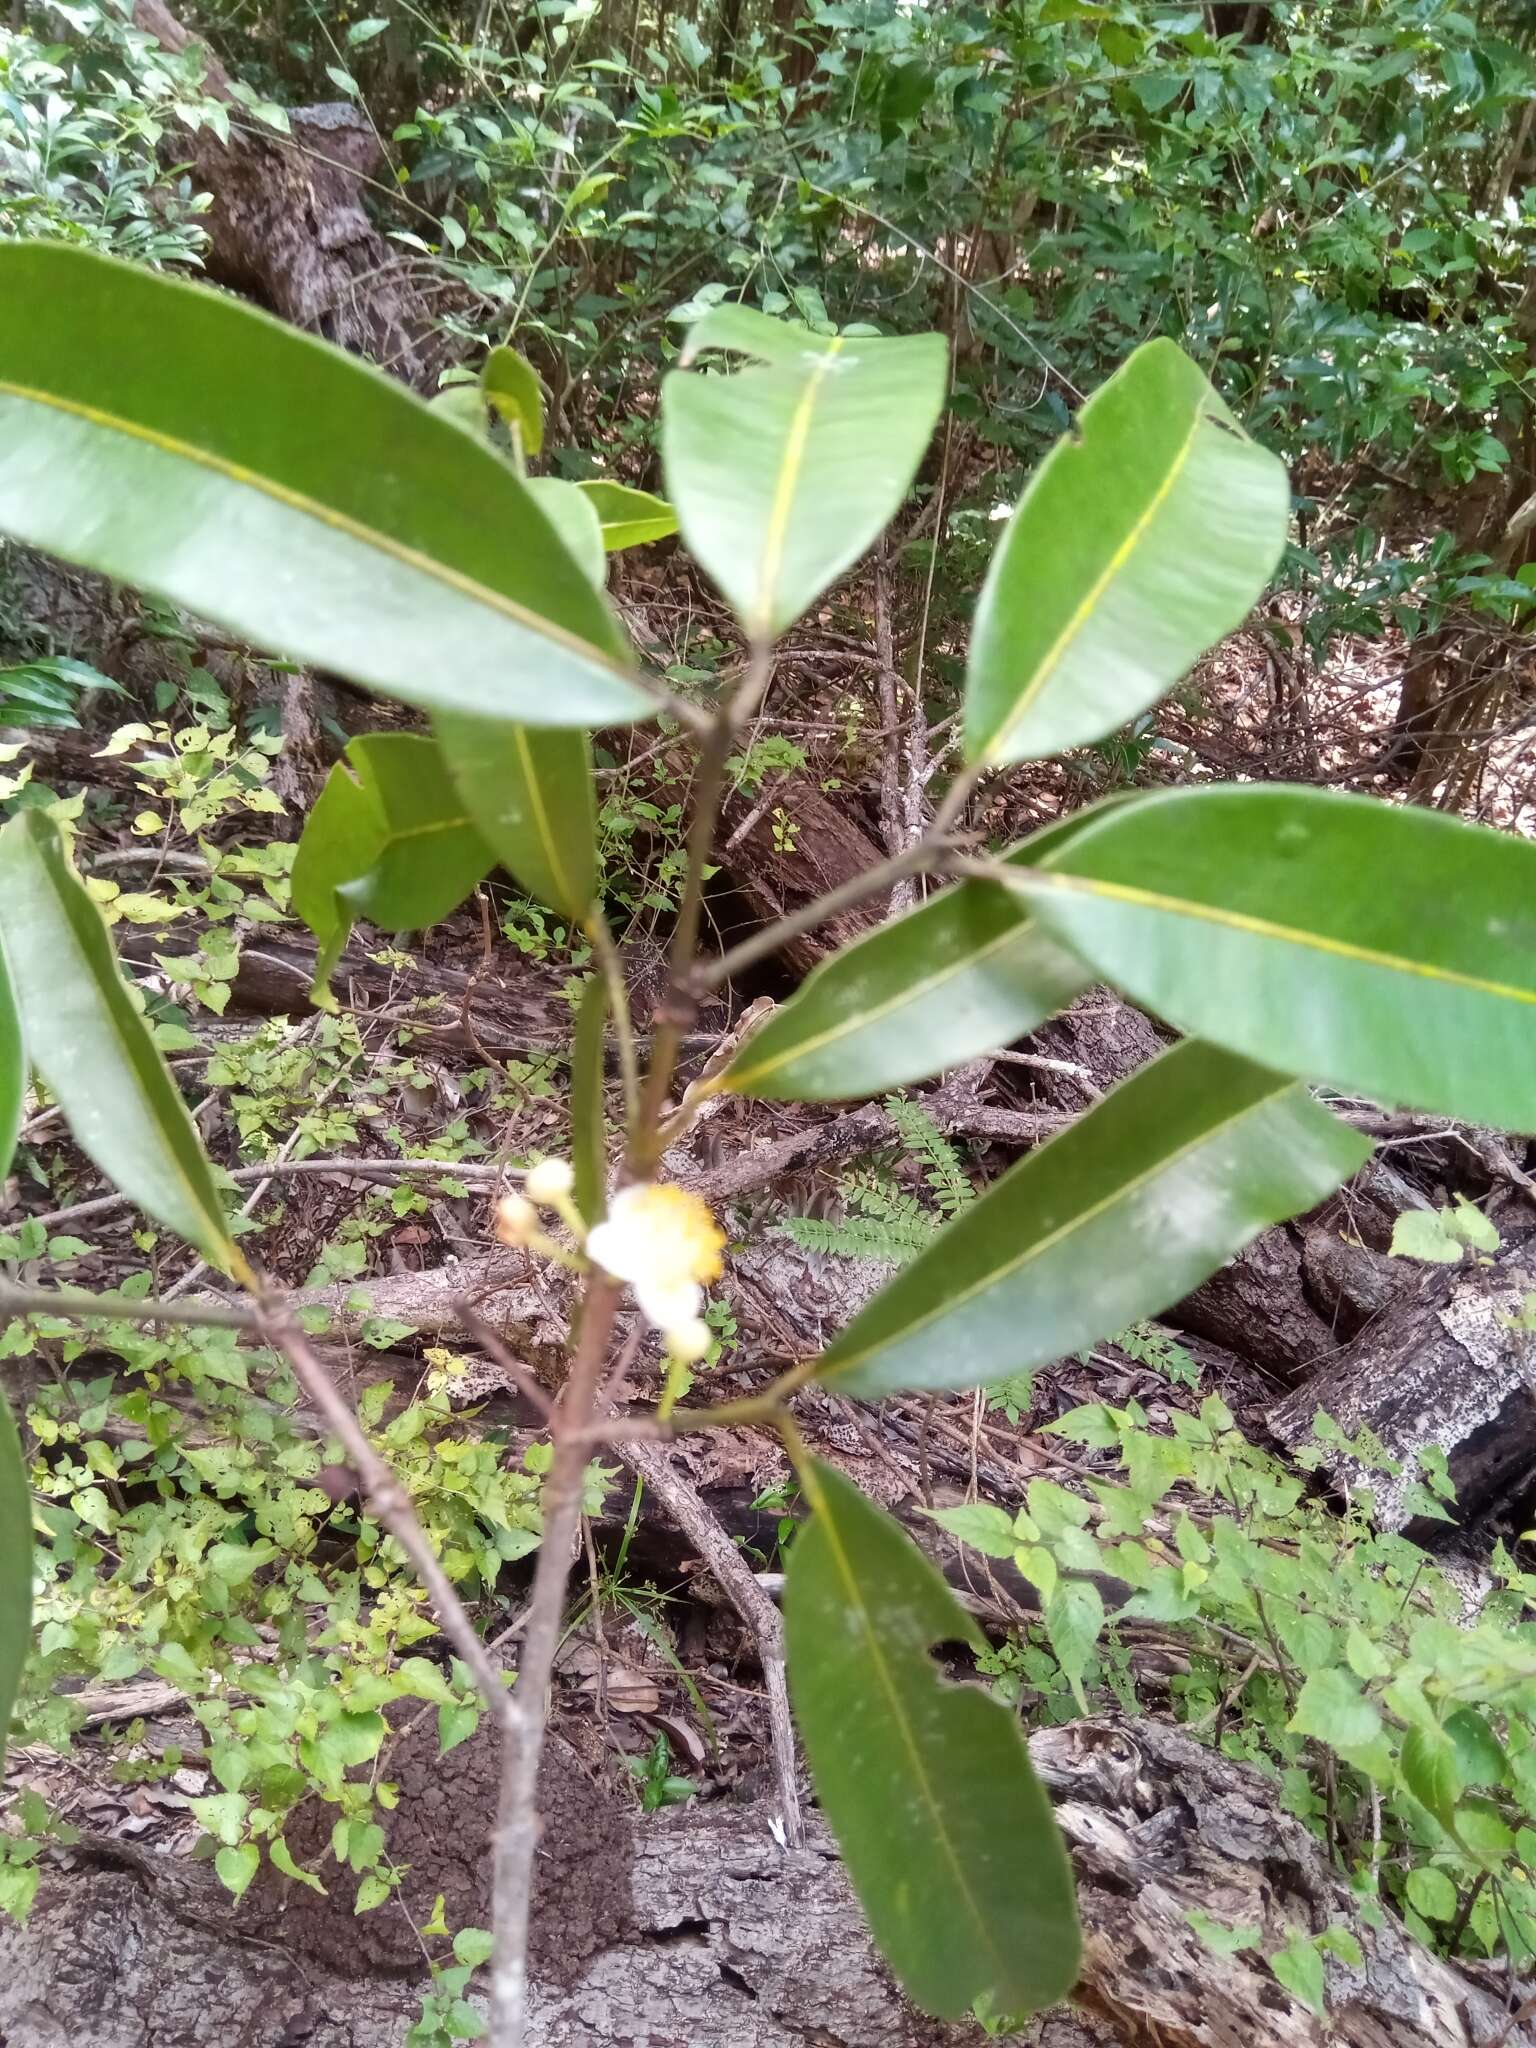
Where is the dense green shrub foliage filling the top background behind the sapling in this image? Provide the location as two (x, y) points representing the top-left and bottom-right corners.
(0, 0), (1536, 667)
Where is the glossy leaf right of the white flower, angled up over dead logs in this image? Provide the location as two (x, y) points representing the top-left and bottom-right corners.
(817, 1040), (1370, 1397)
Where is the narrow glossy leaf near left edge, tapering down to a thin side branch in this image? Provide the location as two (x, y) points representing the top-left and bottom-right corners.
(0, 811), (246, 1274)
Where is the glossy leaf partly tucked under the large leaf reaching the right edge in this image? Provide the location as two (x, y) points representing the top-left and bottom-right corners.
(721, 799), (1118, 1102)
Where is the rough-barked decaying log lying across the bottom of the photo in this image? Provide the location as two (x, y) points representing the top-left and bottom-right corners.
(0, 1716), (1536, 2048)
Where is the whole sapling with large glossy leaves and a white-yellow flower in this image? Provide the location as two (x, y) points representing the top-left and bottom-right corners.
(0, 244), (1536, 2048)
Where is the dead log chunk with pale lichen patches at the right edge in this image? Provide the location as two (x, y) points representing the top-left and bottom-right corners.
(1270, 1251), (1536, 1530)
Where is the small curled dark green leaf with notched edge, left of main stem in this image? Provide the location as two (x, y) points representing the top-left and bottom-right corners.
(293, 733), (493, 989)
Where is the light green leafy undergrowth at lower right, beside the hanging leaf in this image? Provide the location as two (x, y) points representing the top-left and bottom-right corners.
(950, 1399), (1536, 1982)
